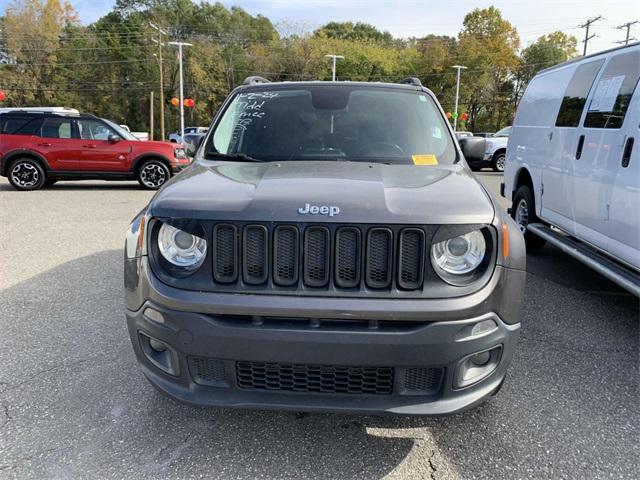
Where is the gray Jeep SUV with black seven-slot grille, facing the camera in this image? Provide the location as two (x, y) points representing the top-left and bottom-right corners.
(125, 78), (525, 414)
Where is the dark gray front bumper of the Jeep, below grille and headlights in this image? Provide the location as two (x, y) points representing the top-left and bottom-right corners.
(125, 257), (524, 415)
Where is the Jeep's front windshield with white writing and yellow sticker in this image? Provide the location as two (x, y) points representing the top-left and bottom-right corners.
(205, 85), (456, 165)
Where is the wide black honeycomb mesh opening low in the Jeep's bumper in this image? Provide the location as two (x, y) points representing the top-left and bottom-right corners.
(236, 362), (393, 395)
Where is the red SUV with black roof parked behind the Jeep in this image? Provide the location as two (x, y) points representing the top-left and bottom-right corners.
(0, 110), (190, 190)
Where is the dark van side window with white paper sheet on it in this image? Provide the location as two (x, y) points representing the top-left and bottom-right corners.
(584, 50), (640, 128)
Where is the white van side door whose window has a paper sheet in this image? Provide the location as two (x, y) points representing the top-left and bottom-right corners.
(571, 48), (640, 262)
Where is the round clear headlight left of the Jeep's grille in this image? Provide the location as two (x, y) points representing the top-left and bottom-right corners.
(158, 223), (207, 272)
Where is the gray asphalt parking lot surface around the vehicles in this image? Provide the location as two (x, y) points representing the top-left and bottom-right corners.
(0, 172), (640, 479)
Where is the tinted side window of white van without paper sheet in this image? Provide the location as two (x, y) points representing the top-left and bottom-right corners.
(556, 60), (604, 127)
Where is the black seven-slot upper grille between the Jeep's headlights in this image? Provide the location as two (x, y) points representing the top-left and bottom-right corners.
(212, 223), (431, 293)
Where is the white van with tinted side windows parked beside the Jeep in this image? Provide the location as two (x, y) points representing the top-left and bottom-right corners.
(502, 43), (640, 296)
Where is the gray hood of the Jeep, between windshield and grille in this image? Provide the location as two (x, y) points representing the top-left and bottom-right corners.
(148, 160), (494, 224)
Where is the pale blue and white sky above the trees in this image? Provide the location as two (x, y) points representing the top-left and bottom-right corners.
(0, 0), (640, 52)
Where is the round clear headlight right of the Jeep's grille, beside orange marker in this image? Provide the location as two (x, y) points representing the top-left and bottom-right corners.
(431, 230), (491, 285)
